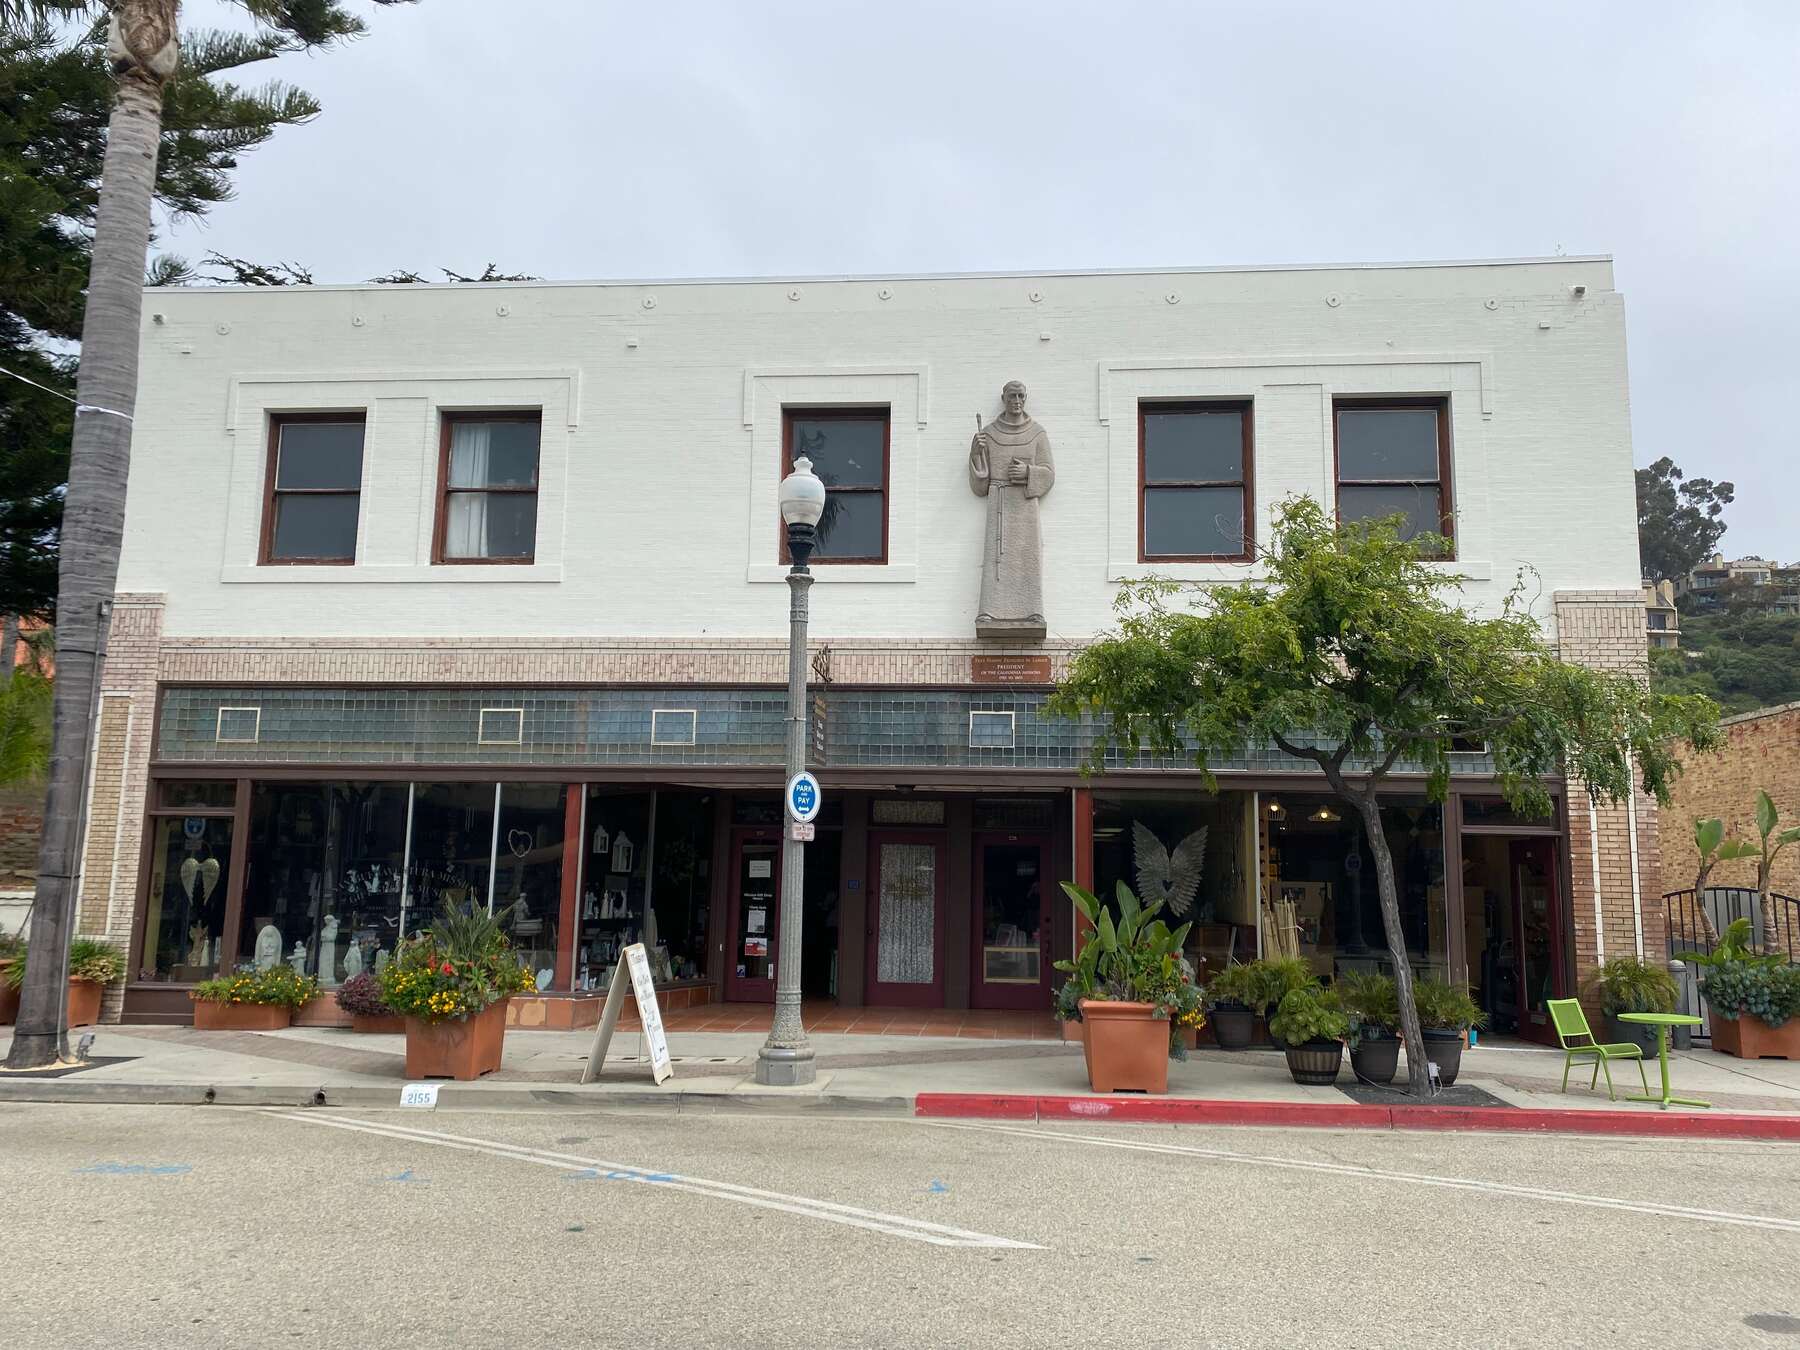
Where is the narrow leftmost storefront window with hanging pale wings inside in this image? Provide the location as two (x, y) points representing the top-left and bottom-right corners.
(139, 813), (232, 985)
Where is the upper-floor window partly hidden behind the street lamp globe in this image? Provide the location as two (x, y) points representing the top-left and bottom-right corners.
(781, 409), (887, 563)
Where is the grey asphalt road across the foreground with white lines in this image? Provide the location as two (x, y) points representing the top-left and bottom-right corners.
(0, 1105), (1800, 1350)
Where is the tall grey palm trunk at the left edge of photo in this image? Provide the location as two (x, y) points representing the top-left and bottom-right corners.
(7, 21), (178, 1069)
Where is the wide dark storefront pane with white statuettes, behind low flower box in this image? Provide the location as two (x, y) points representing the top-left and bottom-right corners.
(236, 783), (409, 988)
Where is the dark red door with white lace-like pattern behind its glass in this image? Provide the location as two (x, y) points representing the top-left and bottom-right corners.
(866, 832), (943, 1008)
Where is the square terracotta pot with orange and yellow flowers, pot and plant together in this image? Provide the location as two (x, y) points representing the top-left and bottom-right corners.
(378, 902), (536, 1080)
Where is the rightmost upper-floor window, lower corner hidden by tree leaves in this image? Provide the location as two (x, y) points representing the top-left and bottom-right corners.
(1332, 398), (1454, 556)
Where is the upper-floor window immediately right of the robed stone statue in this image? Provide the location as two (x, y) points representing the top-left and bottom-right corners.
(1138, 403), (1255, 562)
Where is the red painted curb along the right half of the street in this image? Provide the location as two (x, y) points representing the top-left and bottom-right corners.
(913, 1093), (1800, 1139)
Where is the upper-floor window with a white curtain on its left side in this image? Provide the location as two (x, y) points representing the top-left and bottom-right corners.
(432, 412), (542, 563)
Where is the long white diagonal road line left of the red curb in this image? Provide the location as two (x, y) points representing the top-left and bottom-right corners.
(266, 1111), (1042, 1251)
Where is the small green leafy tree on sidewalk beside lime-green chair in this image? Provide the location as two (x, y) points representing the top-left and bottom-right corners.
(1049, 497), (1719, 1094)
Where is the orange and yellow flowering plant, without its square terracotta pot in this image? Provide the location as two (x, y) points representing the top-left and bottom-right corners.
(378, 904), (536, 1022)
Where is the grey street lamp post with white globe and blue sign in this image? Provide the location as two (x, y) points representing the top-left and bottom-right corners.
(756, 455), (824, 1087)
